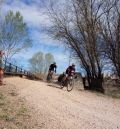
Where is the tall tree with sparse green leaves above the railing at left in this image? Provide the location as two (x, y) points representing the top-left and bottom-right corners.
(0, 11), (32, 59)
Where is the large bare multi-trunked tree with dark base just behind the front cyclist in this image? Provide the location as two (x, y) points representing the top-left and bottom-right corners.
(45, 0), (114, 92)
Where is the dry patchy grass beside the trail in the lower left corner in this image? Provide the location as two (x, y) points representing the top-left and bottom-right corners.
(0, 85), (36, 129)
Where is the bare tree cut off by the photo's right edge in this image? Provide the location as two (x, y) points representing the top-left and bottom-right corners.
(100, 0), (120, 78)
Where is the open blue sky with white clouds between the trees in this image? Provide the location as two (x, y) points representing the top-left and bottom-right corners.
(2, 0), (80, 72)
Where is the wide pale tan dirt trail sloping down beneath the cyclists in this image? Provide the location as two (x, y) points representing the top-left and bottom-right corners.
(5, 78), (120, 129)
